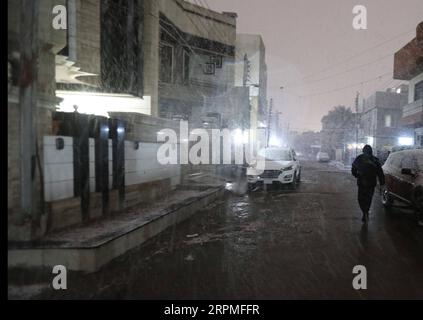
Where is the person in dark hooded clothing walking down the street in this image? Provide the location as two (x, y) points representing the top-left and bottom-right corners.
(351, 145), (385, 223)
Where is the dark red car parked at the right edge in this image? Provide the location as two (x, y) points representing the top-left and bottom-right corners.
(382, 149), (423, 218)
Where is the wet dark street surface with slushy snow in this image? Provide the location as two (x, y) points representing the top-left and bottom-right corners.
(9, 162), (423, 299)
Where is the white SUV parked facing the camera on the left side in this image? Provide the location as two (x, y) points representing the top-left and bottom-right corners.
(247, 148), (301, 189)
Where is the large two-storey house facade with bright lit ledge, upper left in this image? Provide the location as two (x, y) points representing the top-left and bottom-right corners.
(51, 0), (239, 126)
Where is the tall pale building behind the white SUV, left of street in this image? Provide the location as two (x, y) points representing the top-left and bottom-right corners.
(235, 34), (268, 145)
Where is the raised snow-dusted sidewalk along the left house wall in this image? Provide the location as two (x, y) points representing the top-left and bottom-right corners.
(8, 181), (224, 272)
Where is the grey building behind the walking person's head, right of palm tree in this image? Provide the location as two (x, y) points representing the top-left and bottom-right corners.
(359, 85), (408, 151)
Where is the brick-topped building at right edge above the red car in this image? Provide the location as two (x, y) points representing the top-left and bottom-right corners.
(394, 22), (423, 146)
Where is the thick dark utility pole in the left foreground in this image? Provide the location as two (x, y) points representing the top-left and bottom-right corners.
(19, 0), (40, 217)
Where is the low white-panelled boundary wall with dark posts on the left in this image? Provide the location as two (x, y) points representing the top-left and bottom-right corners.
(38, 113), (181, 232)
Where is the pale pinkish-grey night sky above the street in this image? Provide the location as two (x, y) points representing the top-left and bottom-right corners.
(204, 0), (423, 131)
